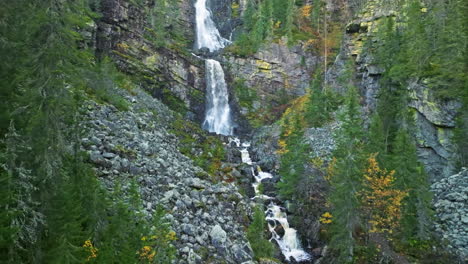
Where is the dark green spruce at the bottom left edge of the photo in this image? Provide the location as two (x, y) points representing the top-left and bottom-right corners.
(0, 124), (44, 263)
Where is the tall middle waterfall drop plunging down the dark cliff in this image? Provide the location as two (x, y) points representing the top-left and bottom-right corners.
(203, 59), (233, 135)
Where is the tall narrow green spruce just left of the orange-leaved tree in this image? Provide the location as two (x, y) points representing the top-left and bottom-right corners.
(329, 86), (365, 263)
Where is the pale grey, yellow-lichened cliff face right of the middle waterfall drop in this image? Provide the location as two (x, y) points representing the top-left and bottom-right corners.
(224, 39), (319, 124)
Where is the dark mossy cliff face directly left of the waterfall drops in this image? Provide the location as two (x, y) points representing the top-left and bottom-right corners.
(96, 0), (205, 121)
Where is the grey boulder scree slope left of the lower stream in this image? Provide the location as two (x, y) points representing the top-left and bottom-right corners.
(82, 89), (252, 264)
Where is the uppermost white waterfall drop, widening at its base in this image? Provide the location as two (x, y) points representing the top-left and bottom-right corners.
(195, 0), (230, 52)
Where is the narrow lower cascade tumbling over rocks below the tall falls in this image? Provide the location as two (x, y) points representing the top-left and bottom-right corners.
(230, 138), (311, 262)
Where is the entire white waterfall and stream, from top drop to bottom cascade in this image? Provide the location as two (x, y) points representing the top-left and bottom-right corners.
(195, 0), (310, 262)
